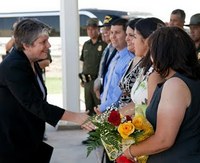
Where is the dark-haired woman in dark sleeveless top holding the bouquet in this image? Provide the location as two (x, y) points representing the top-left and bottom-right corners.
(124, 27), (200, 163)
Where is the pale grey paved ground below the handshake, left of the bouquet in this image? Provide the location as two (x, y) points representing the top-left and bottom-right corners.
(46, 125), (102, 163)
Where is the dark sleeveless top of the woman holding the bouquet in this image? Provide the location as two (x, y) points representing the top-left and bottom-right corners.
(146, 73), (200, 163)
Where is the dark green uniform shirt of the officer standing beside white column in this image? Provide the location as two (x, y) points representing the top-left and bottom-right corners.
(80, 37), (107, 77)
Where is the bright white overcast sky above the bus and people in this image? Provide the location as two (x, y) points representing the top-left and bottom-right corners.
(0, 0), (200, 22)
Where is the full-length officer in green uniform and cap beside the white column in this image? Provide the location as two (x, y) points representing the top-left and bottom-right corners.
(79, 18), (107, 115)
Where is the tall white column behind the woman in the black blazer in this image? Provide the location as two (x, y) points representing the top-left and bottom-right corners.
(59, 0), (80, 129)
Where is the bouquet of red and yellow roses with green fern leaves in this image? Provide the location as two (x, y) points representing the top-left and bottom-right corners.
(87, 106), (154, 163)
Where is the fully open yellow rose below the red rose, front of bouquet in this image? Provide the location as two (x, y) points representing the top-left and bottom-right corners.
(118, 121), (135, 139)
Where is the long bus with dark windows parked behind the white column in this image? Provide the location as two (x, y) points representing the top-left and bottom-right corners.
(0, 8), (152, 55)
